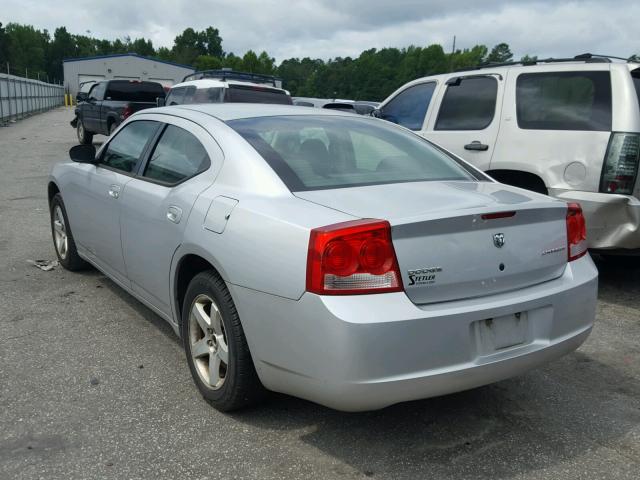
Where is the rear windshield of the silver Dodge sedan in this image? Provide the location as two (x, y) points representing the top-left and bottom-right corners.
(227, 115), (478, 191)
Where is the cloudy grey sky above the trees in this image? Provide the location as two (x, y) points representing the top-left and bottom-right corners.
(0, 0), (640, 63)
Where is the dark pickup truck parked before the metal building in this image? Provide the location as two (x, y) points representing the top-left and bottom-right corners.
(71, 80), (165, 144)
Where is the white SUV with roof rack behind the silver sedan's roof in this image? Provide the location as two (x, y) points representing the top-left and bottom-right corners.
(164, 70), (292, 106)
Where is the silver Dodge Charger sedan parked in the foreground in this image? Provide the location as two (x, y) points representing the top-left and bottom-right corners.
(48, 104), (597, 411)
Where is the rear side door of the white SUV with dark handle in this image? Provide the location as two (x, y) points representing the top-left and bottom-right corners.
(422, 74), (504, 170)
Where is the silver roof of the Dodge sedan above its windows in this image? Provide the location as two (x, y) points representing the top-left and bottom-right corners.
(148, 103), (366, 122)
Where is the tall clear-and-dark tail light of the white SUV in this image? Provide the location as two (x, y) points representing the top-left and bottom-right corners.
(600, 132), (640, 195)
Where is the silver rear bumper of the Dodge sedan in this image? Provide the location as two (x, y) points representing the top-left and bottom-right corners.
(230, 255), (598, 411)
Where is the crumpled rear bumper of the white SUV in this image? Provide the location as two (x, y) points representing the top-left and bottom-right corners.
(549, 190), (640, 250)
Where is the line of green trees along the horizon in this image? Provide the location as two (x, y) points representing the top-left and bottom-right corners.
(0, 23), (535, 100)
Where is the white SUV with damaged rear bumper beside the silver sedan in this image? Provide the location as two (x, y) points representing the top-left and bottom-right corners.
(374, 54), (640, 253)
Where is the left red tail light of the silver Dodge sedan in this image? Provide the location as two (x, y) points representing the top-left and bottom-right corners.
(307, 219), (402, 295)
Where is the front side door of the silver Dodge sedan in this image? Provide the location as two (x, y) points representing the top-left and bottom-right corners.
(65, 120), (159, 285)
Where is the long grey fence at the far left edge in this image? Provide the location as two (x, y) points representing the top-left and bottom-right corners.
(0, 73), (64, 124)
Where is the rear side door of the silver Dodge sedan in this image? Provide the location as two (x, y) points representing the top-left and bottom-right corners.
(121, 115), (222, 316)
